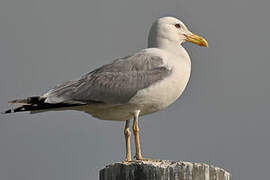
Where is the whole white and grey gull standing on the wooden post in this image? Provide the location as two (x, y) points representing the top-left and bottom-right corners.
(4, 17), (208, 161)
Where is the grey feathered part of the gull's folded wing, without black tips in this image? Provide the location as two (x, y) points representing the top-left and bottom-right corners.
(45, 54), (171, 104)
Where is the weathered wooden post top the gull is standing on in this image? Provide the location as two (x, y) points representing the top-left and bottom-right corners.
(99, 160), (230, 180)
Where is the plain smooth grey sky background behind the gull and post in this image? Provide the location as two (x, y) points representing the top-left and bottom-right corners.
(0, 0), (270, 180)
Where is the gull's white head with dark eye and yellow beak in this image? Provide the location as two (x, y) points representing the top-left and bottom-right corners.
(148, 17), (208, 49)
